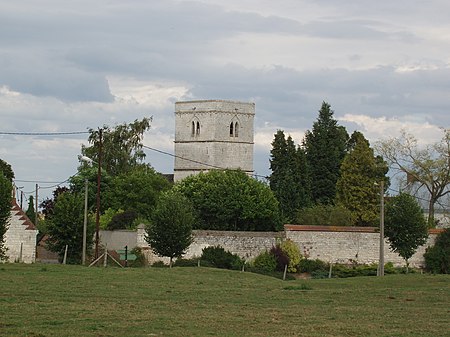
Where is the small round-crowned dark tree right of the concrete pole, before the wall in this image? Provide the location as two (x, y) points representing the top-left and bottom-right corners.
(384, 193), (428, 268)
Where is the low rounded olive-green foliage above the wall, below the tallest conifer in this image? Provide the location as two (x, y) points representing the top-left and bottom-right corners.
(296, 205), (354, 226)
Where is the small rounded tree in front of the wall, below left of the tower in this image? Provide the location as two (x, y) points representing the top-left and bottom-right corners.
(146, 190), (195, 267)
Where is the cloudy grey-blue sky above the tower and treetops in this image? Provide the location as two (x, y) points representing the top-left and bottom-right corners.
(0, 0), (450, 203)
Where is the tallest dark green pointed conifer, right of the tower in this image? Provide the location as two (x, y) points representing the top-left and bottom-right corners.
(304, 102), (348, 204)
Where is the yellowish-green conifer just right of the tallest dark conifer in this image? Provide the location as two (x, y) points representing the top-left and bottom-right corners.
(336, 131), (389, 226)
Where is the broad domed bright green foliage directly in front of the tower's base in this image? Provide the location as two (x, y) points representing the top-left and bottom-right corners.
(175, 170), (282, 231)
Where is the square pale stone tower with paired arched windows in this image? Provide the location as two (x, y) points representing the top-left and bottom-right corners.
(174, 100), (255, 181)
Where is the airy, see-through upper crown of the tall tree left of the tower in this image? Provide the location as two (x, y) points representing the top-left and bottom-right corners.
(81, 118), (151, 176)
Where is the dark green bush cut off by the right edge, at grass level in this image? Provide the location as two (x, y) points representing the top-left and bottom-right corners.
(423, 228), (450, 274)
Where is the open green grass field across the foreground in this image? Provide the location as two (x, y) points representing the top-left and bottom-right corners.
(0, 264), (450, 336)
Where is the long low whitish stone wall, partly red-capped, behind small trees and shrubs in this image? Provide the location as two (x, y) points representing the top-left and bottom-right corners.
(97, 225), (440, 268)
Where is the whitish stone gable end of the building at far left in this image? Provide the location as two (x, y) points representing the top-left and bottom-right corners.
(5, 199), (38, 263)
